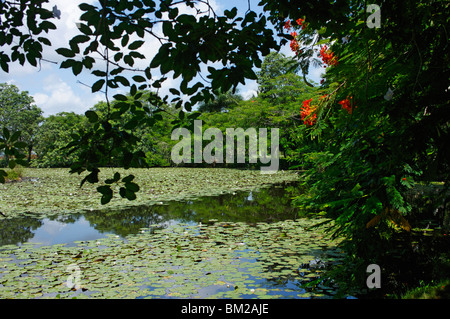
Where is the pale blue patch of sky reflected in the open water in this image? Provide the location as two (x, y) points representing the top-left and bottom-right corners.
(29, 217), (112, 245)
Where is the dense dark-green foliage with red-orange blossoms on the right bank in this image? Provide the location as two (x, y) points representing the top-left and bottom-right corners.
(263, 1), (450, 296)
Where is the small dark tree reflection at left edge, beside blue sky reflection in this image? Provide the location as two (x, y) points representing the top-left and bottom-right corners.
(0, 217), (42, 246)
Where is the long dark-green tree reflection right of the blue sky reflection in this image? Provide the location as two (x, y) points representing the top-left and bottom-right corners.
(80, 187), (298, 236)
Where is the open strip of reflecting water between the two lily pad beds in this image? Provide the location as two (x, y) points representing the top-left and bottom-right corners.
(0, 185), (298, 245)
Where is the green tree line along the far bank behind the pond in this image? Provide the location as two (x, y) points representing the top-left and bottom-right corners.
(0, 52), (317, 168)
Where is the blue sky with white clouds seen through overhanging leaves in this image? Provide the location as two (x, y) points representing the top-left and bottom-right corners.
(0, 0), (322, 116)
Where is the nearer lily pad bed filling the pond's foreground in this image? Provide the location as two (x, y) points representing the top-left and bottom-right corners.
(0, 219), (341, 298)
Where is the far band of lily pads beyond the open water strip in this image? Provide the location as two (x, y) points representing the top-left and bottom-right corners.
(0, 168), (298, 219)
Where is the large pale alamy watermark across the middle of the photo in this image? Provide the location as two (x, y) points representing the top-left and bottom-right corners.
(171, 120), (280, 174)
